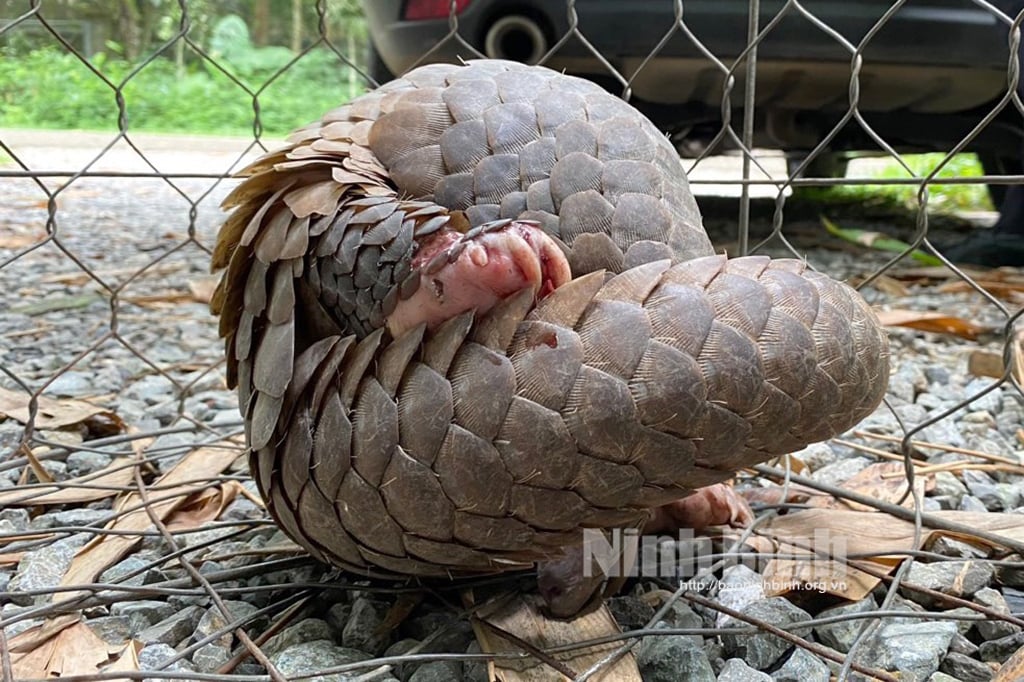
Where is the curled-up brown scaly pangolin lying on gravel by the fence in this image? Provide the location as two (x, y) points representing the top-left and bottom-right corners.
(212, 59), (889, 611)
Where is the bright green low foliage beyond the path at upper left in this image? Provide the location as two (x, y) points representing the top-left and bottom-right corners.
(0, 33), (362, 135)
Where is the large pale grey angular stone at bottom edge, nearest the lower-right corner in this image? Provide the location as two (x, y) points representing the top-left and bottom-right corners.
(857, 621), (956, 682)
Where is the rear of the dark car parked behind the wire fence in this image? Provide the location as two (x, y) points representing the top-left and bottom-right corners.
(364, 0), (1024, 191)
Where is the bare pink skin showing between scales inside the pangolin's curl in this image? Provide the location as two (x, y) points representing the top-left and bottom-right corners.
(387, 221), (571, 337)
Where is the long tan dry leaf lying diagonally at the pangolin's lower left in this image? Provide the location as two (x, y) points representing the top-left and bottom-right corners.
(53, 447), (243, 601)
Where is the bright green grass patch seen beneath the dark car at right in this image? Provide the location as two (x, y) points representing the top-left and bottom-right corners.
(801, 154), (992, 212)
